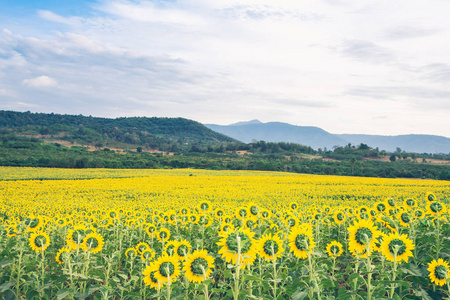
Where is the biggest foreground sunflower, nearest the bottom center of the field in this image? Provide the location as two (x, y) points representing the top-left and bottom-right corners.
(217, 228), (256, 269)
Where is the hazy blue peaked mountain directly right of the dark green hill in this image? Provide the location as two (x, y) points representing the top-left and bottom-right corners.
(205, 120), (347, 149)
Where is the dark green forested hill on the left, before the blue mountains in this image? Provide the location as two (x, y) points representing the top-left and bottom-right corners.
(0, 111), (235, 151)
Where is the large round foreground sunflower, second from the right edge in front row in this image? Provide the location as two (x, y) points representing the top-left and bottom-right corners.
(380, 233), (414, 262)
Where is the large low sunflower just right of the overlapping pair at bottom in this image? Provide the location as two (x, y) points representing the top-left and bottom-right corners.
(183, 250), (214, 283)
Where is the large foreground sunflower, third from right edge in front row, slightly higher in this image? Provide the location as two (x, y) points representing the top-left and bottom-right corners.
(348, 220), (381, 256)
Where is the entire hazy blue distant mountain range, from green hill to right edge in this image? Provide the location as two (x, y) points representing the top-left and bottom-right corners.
(205, 120), (450, 153)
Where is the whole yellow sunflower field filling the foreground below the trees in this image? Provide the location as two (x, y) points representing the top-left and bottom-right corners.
(0, 167), (450, 299)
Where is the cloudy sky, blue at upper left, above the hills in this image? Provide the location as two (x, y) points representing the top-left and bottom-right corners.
(0, 0), (450, 137)
